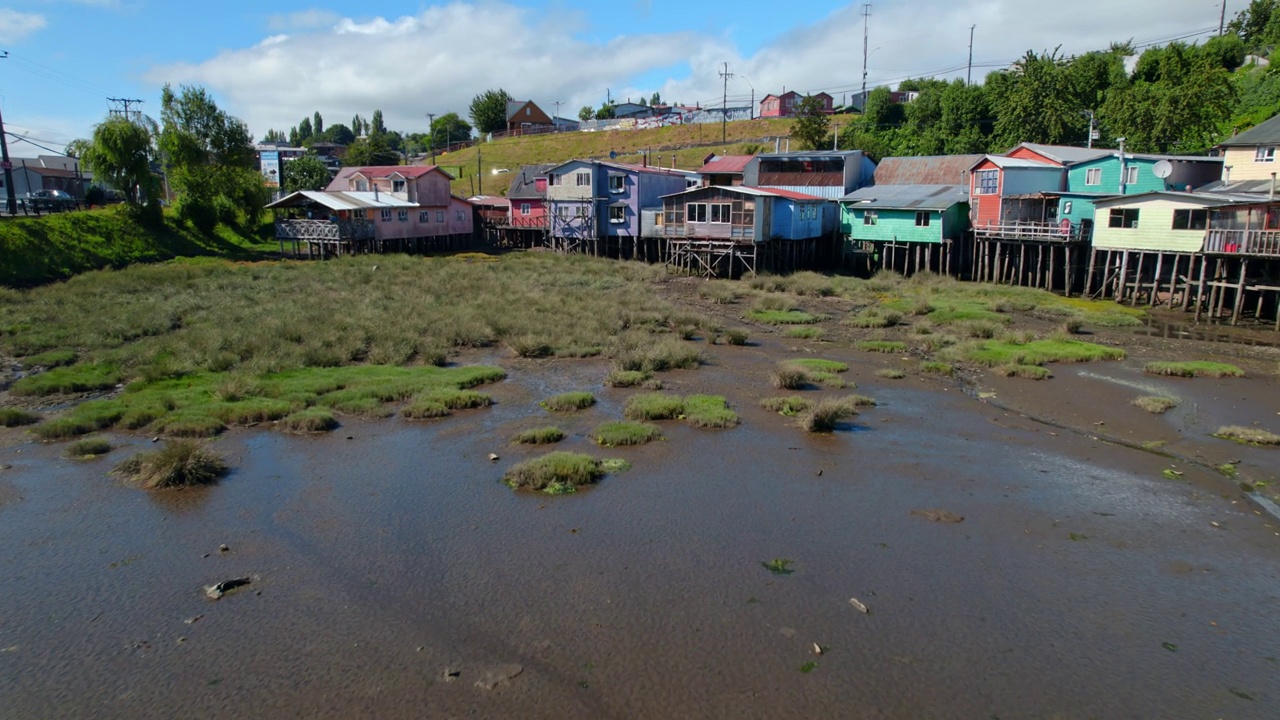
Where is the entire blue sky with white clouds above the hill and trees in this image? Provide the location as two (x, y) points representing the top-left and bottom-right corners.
(0, 0), (1245, 155)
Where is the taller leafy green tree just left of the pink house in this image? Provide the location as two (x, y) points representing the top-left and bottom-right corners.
(159, 85), (261, 232)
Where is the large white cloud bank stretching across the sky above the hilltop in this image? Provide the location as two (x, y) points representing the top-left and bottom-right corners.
(145, 0), (1233, 135)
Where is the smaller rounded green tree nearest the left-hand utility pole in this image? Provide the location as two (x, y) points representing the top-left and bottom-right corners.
(73, 117), (160, 208)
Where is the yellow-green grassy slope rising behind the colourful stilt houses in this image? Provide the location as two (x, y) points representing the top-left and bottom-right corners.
(436, 119), (792, 197)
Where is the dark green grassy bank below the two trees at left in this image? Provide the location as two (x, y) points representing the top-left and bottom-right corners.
(0, 206), (274, 287)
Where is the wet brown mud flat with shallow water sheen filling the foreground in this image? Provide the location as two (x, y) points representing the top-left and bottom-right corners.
(0, 336), (1280, 719)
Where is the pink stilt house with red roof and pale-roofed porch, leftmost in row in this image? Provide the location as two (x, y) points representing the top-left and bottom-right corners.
(266, 165), (475, 256)
